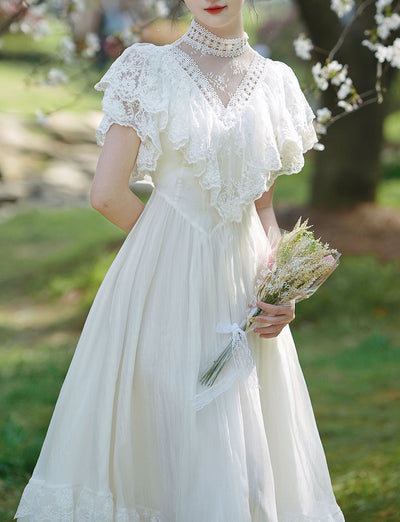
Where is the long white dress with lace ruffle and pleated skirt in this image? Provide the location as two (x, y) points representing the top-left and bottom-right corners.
(15, 22), (344, 522)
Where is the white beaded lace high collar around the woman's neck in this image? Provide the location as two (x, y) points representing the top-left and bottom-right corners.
(182, 19), (250, 57)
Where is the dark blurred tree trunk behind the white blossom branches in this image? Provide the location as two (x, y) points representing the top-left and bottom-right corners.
(297, 0), (384, 208)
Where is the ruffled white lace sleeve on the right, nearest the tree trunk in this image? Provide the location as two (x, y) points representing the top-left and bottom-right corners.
(274, 62), (318, 177)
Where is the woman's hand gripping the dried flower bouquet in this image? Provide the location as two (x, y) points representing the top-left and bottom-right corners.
(253, 300), (295, 339)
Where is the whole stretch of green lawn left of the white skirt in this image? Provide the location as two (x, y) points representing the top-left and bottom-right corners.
(0, 209), (124, 521)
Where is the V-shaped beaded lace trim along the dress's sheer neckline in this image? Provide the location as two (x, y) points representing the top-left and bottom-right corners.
(166, 46), (265, 117)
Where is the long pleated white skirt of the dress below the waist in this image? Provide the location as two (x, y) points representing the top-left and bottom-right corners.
(17, 186), (342, 522)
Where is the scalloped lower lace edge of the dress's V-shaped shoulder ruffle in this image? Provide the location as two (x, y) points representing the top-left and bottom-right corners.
(91, 45), (317, 221)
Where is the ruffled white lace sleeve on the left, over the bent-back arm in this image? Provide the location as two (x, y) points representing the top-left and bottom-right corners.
(94, 43), (168, 181)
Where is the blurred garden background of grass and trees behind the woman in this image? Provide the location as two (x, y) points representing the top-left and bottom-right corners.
(0, 0), (400, 522)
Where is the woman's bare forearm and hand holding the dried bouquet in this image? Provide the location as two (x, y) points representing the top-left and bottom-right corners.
(254, 183), (295, 339)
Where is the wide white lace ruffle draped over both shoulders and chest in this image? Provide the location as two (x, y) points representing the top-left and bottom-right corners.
(96, 44), (317, 221)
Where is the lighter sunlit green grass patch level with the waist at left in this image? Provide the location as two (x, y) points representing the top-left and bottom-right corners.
(0, 208), (123, 304)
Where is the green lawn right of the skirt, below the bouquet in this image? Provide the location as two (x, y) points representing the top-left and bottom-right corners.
(293, 256), (400, 522)
